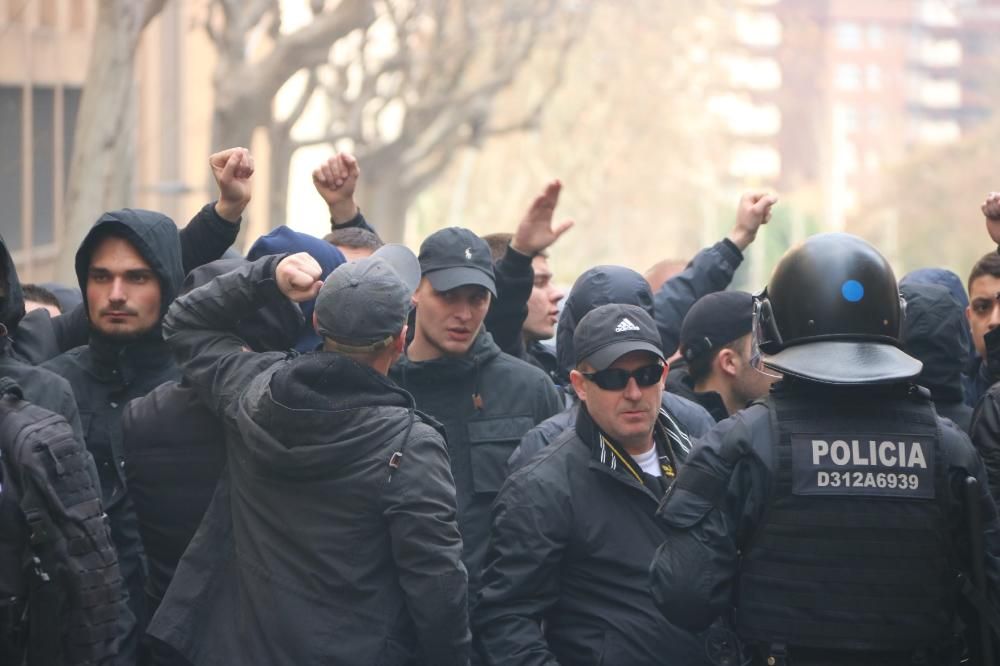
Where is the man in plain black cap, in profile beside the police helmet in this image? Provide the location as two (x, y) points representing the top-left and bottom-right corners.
(667, 291), (775, 422)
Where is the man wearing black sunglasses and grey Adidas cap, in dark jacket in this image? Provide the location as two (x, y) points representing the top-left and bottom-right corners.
(473, 304), (711, 666)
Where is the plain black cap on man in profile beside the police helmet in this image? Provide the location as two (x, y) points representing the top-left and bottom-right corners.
(680, 291), (753, 363)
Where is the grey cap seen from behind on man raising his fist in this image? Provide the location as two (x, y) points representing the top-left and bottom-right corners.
(315, 244), (420, 353)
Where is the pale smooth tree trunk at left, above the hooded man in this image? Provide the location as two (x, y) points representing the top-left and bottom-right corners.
(56, 0), (167, 284)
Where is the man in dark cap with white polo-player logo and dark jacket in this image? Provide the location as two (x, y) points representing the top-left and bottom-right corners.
(392, 227), (562, 598)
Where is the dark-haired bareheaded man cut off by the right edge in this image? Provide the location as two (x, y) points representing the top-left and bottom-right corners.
(965, 252), (1000, 407)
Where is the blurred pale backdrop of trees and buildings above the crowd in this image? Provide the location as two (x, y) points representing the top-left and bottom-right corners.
(0, 0), (1000, 288)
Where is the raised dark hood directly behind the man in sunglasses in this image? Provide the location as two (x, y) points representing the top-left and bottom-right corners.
(556, 266), (653, 384)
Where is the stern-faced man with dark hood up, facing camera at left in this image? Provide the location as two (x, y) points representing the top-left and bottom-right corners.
(44, 209), (184, 660)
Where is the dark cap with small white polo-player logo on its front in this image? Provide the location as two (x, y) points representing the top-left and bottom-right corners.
(419, 227), (497, 297)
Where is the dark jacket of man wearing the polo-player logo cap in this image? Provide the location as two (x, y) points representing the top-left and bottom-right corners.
(391, 331), (562, 594)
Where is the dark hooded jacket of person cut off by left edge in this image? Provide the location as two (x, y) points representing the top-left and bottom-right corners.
(0, 237), (83, 444)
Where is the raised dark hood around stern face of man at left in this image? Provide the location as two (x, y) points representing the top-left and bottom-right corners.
(76, 208), (184, 322)
